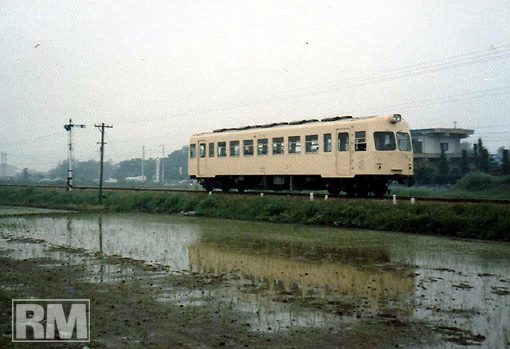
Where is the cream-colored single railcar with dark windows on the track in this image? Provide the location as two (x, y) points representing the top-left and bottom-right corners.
(188, 114), (413, 196)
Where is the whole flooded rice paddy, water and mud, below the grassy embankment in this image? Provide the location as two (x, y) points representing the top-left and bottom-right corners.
(0, 208), (510, 348)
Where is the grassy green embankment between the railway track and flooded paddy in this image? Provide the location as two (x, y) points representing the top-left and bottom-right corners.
(0, 187), (510, 241)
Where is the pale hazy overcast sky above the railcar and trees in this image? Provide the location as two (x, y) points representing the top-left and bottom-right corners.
(0, 0), (510, 170)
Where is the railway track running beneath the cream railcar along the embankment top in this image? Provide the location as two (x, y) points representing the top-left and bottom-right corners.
(0, 184), (510, 205)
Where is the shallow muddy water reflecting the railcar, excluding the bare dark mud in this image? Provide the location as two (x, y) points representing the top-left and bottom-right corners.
(0, 214), (510, 348)
